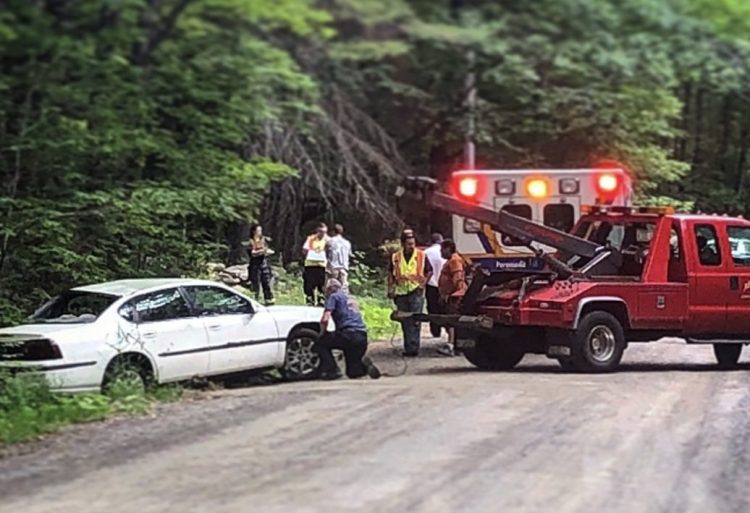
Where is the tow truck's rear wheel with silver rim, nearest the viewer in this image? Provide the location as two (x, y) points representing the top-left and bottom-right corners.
(569, 311), (627, 373)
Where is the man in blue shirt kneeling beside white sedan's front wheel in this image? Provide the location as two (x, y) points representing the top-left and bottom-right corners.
(315, 279), (380, 379)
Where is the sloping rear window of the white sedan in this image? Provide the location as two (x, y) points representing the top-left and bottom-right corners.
(29, 290), (117, 324)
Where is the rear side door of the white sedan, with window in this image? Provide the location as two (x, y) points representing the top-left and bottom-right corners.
(120, 288), (209, 381)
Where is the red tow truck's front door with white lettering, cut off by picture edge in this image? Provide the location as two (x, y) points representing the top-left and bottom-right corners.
(726, 224), (750, 337)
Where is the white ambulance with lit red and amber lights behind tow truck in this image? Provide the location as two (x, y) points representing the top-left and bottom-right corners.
(452, 163), (633, 271)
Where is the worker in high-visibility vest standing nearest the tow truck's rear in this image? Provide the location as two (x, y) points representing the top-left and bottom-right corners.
(388, 229), (432, 356)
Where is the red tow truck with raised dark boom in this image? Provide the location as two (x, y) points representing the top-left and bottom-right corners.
(393, 177), (750, 372)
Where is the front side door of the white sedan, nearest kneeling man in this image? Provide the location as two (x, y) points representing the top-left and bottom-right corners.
(185, 285), (284, 374)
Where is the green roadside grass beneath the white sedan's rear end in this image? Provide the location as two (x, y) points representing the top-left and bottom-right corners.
(0, 372), (182, 445)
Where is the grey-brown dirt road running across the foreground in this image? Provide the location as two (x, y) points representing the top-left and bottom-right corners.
(0, 336), (750, 513)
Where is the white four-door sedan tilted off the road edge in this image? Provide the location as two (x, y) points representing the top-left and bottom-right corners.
(0, 279), (322, 392)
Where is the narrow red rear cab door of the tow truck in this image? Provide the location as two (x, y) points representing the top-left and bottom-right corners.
(685, 222), (729, 336)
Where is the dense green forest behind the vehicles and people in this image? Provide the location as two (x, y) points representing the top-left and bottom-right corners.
(0, 0), (750, 324)
